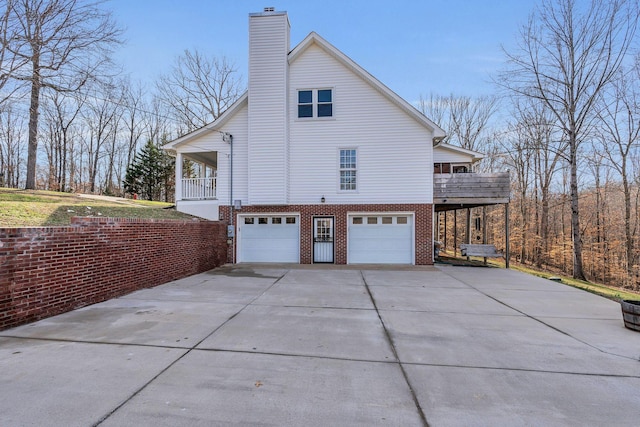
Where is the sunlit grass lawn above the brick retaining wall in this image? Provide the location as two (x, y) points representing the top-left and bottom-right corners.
(0, 188), (198, 228)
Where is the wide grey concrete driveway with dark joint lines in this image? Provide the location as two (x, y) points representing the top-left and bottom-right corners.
(0, 266), (640, 426)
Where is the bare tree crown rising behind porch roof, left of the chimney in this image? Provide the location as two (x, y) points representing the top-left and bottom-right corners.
(156, 50), (243, 133)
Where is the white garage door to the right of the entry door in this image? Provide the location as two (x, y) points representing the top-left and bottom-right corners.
(347, 214), (414, 264)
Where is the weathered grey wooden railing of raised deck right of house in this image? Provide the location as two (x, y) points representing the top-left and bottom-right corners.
(433, 172), (511, 211)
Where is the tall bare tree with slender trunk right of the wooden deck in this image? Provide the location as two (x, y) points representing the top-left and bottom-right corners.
(498, 0), (638, 279)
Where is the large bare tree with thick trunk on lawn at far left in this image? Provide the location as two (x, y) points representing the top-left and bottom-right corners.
(7, 0), (121, 189)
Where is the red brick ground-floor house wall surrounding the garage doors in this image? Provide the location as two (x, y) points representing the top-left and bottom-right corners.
(220, 204), (433, 265)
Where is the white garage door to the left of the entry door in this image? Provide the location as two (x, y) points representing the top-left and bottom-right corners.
(238, 215), (300, 263)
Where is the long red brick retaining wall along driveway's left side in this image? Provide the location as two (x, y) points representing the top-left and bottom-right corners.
(0, 218), (227, 329)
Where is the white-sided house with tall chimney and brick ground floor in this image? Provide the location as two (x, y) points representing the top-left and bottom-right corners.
(164, 10), (448, 264)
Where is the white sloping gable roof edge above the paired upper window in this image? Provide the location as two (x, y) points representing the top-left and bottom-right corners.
(289, 32), (446, 140)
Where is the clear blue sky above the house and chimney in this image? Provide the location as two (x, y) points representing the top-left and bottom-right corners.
(106, 0), (538, 103)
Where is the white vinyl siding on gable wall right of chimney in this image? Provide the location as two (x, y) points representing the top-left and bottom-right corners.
(289, 45), (433, 204)
